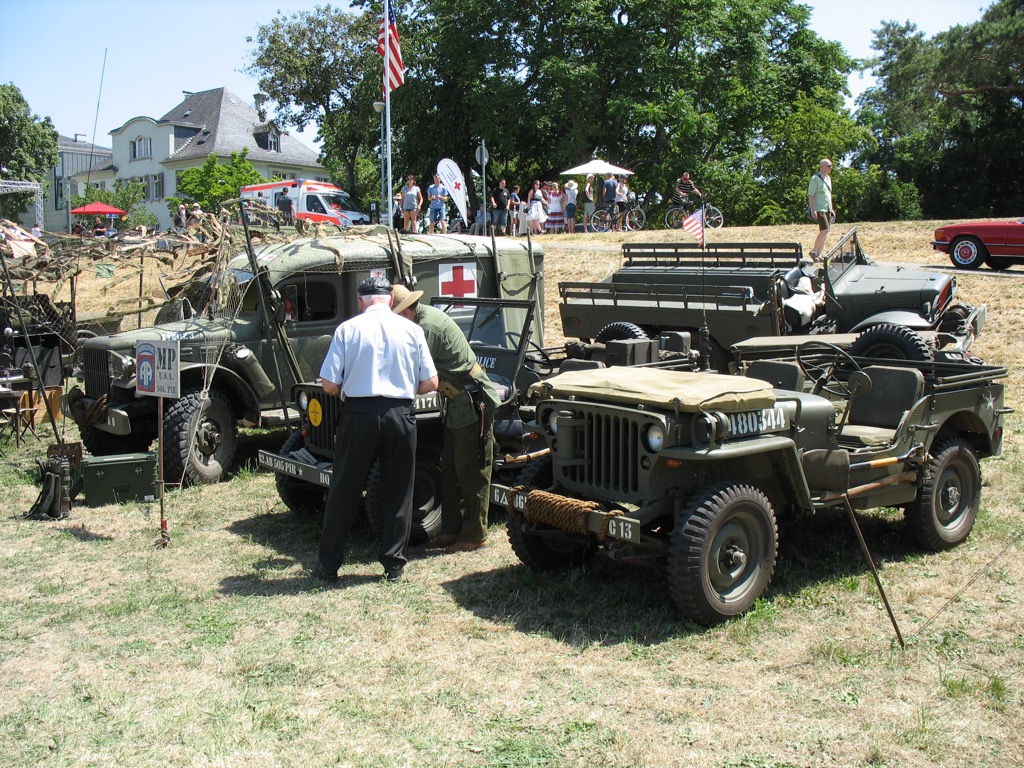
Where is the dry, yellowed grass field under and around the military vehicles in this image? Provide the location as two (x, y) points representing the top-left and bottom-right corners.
(0, 222), (1024, 768)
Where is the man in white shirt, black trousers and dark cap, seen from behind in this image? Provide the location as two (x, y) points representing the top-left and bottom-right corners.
(314, 278), (437, 582)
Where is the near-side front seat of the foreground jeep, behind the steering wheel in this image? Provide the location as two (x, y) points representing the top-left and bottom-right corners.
(840, 366), (925, 445)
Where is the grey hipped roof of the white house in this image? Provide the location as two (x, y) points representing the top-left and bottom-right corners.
(158, 88), (319, 166)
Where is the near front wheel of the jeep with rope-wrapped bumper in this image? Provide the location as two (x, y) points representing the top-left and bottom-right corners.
(669, 483), (778, 626)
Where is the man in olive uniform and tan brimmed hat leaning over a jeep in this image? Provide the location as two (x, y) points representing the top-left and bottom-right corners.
(393, 286), (501, 554)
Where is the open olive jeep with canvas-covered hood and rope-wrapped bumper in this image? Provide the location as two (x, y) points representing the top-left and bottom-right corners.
(493, 340), (1012, 625)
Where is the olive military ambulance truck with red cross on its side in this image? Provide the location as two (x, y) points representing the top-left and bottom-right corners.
(63, 229), (543, 484)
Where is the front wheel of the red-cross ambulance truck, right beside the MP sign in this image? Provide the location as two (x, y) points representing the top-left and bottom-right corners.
(164, 387), (236, 485)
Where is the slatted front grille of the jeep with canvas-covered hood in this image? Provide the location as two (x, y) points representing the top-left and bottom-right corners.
(555, 403), (647, 498)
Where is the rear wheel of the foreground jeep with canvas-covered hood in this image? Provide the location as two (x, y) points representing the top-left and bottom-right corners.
(904, 437), (981, 552)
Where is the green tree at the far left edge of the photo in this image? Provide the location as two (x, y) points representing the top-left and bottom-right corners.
(0, 83), (57, 219)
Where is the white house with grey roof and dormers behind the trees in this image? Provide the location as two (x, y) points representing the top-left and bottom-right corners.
(75, 88), (323, 229)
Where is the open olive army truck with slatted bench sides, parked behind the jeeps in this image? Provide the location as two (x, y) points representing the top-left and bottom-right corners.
(558, 229), (985, 373)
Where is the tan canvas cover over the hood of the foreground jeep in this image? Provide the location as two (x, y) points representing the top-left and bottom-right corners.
(529, 368), (775, 414)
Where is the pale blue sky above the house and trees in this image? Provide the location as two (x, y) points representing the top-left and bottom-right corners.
(0, 0), (988, 153)
